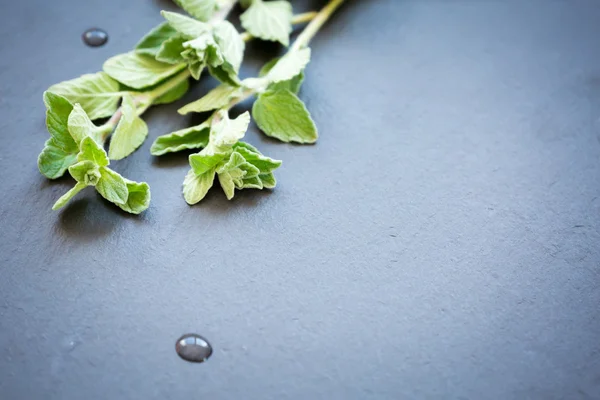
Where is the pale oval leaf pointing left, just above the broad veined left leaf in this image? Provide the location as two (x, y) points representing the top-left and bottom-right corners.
(102, 51), (185, 89)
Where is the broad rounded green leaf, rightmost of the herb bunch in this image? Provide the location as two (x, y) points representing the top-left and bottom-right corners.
(252, 90), (318, 143)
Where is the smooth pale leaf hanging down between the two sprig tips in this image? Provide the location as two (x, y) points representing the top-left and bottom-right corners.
(108, 95), (148, 160)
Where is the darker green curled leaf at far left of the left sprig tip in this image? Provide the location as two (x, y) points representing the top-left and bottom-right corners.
(38, 92), (79, 179)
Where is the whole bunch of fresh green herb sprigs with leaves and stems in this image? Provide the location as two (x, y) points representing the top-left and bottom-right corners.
(38, 0), (344, 214)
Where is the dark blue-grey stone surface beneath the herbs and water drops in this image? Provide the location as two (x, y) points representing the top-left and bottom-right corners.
(0, 0), (600, 400)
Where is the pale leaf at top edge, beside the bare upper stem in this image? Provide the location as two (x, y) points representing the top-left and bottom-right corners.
(240, 0), (292, 46)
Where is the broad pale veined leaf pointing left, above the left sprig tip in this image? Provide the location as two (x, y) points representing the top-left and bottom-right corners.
(48, 72), (123, 120)
